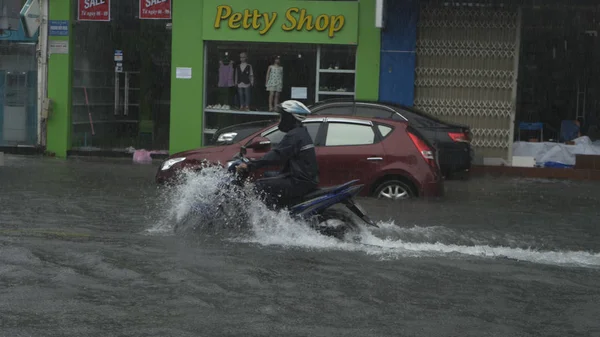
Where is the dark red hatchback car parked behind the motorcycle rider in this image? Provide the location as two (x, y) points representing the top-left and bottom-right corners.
(156, 115), (444, 200)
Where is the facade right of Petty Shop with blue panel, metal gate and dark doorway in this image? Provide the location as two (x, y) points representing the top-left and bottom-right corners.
(380, 0), (600, 165)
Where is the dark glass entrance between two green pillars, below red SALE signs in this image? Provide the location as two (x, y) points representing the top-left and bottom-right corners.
(71, 0), (171, 152)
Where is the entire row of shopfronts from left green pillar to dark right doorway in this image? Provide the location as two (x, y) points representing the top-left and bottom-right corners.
(38, 0), (600, 164)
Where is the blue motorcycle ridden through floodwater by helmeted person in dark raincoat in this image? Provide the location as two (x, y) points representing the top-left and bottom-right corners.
(177, 137), (379, 241)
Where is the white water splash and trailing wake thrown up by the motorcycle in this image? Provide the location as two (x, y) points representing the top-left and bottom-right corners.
(148, 168), (600, 268)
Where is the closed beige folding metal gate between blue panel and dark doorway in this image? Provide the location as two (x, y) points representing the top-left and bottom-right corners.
(415, 3), (519, 160)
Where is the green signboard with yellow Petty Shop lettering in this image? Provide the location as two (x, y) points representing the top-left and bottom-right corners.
(202, 0), (359, 44)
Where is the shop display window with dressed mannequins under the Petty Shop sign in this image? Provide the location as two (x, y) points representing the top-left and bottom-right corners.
(204, 41), (356, 141)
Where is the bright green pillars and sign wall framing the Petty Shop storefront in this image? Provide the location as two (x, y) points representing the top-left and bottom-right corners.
(47, 0), (381, 157)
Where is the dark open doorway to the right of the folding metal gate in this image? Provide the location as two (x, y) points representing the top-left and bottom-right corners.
(515, 5), (600, 141)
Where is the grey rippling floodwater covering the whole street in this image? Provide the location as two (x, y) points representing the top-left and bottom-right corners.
(0, 156), (600, 337)
